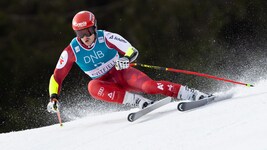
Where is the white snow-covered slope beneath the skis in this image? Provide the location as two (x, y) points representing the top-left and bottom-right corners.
(0, 81), (267, 150)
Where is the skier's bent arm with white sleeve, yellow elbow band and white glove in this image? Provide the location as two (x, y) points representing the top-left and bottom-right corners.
(105, 31), (139, 70)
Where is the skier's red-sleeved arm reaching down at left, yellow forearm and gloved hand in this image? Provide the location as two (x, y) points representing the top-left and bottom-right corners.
(47, 45), (75, 113)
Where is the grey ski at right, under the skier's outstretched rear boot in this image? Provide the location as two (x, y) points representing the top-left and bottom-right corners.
(177, 96), (216, 111)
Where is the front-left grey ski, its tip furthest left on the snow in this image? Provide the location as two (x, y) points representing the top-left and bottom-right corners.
(127, 97), (172, 122)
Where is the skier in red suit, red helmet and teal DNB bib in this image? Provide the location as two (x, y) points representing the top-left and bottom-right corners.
(47, 11), (208, 113)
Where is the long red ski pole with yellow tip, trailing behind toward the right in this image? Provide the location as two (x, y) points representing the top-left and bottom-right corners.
(130, 63), (254, 87)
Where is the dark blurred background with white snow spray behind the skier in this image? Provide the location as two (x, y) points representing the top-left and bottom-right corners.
(0, 0), (267, 133)
